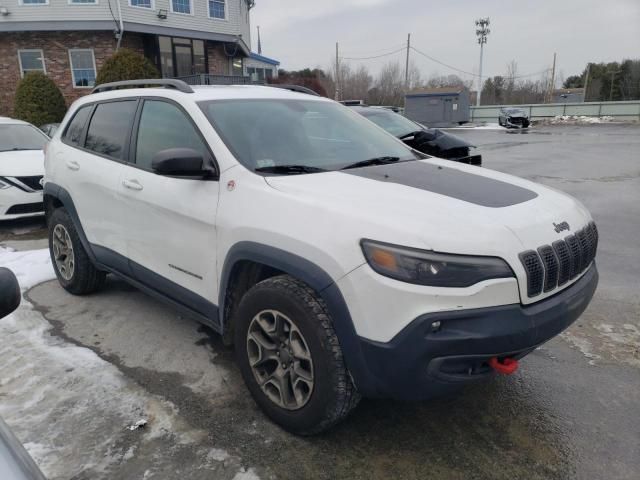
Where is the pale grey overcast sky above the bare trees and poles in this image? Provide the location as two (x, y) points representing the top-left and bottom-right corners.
(251, 0), (640, 85)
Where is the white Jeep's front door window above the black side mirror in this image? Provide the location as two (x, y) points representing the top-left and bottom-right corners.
(136, 100), (210, 170)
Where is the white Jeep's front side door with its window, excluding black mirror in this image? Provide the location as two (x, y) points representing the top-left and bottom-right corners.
(120, 98), (219, 317)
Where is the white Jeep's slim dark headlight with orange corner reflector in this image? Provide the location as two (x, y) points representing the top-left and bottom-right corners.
(360, 240), (515, 287)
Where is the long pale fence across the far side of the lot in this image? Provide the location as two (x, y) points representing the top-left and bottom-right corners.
(471, 100), (640, 123)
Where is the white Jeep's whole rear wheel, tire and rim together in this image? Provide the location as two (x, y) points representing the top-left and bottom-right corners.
(48, 208), (106, 295)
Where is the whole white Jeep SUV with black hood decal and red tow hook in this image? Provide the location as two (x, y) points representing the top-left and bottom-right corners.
(45, 80), (598, 434)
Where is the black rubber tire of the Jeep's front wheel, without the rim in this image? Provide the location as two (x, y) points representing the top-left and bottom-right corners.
(234, 275), (360, 435)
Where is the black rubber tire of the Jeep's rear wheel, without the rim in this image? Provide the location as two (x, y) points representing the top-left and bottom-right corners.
(47, 208), (107, 295)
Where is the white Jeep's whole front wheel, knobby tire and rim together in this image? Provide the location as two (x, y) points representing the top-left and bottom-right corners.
(234, 275), (360, 435)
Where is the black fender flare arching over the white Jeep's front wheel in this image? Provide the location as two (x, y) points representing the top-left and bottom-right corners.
(218, 241), (371, 393)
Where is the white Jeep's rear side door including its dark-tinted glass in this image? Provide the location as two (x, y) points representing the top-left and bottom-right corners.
(56, 99), (138, 272)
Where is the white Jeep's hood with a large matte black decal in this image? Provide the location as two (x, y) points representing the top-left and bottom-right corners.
(266, 159), (590, 270)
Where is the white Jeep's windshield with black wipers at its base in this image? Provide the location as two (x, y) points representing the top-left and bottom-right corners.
(200, 99), (422, 173)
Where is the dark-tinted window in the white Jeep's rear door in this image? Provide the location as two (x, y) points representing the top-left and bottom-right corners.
(85, 100), (137, 160)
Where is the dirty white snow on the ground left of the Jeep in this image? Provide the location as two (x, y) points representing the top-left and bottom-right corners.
(0, 247), (258, 480)
